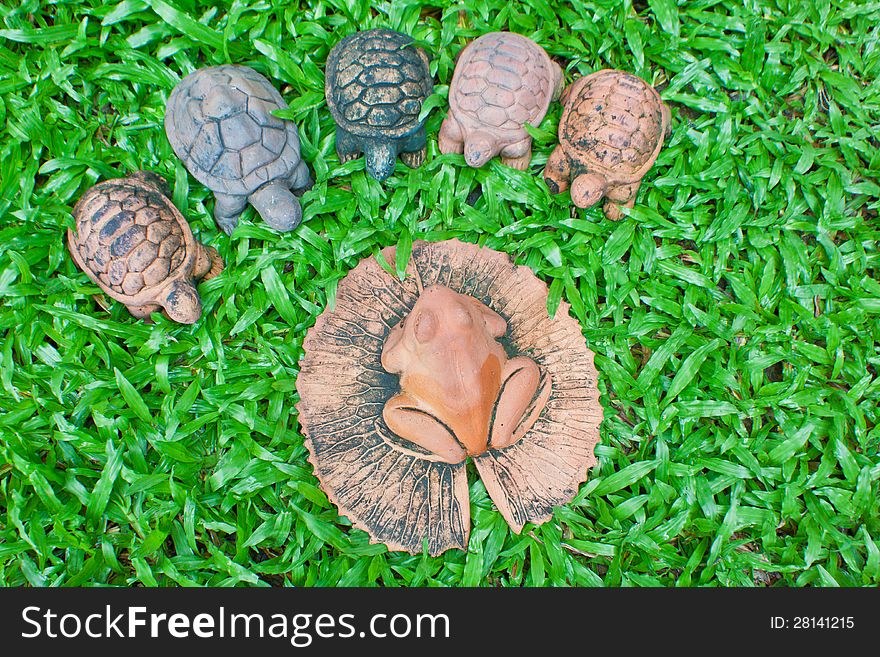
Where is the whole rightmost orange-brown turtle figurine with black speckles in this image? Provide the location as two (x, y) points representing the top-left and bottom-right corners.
(544, 70), (672, 220)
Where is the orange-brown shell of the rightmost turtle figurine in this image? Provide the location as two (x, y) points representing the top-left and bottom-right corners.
(559, 70), (666, 183)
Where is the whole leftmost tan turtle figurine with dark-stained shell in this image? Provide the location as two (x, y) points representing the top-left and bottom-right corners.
(67, 171), (223, 324)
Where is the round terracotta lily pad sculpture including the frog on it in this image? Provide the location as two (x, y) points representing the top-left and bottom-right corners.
(296, 240), (602, 555)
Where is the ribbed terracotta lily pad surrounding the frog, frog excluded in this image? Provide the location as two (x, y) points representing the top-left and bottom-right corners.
(296, 240), (602, 555)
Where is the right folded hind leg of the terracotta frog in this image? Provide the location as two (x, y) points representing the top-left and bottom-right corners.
(489, 356), (549, 449)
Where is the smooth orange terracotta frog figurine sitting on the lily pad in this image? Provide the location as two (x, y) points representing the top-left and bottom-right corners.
(382, 285), (546, 463)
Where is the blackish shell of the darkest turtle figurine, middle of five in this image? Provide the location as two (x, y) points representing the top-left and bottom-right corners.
(325, 29), (434, 137)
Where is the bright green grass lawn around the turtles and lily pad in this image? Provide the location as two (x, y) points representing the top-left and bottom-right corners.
(0, 0), (880, 586)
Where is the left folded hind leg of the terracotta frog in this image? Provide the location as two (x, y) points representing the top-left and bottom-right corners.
(382, 392), (467, 463)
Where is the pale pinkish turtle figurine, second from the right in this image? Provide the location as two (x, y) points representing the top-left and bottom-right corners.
(438, 32), (563, 170)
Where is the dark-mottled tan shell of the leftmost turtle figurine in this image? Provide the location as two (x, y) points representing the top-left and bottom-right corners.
(68, 177), (196, 306)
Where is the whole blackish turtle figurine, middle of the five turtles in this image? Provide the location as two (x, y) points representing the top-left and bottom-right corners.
(325, 29), (434, 180)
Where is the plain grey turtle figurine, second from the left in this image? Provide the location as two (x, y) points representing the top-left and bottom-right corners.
(165, 65), (312, 234)
